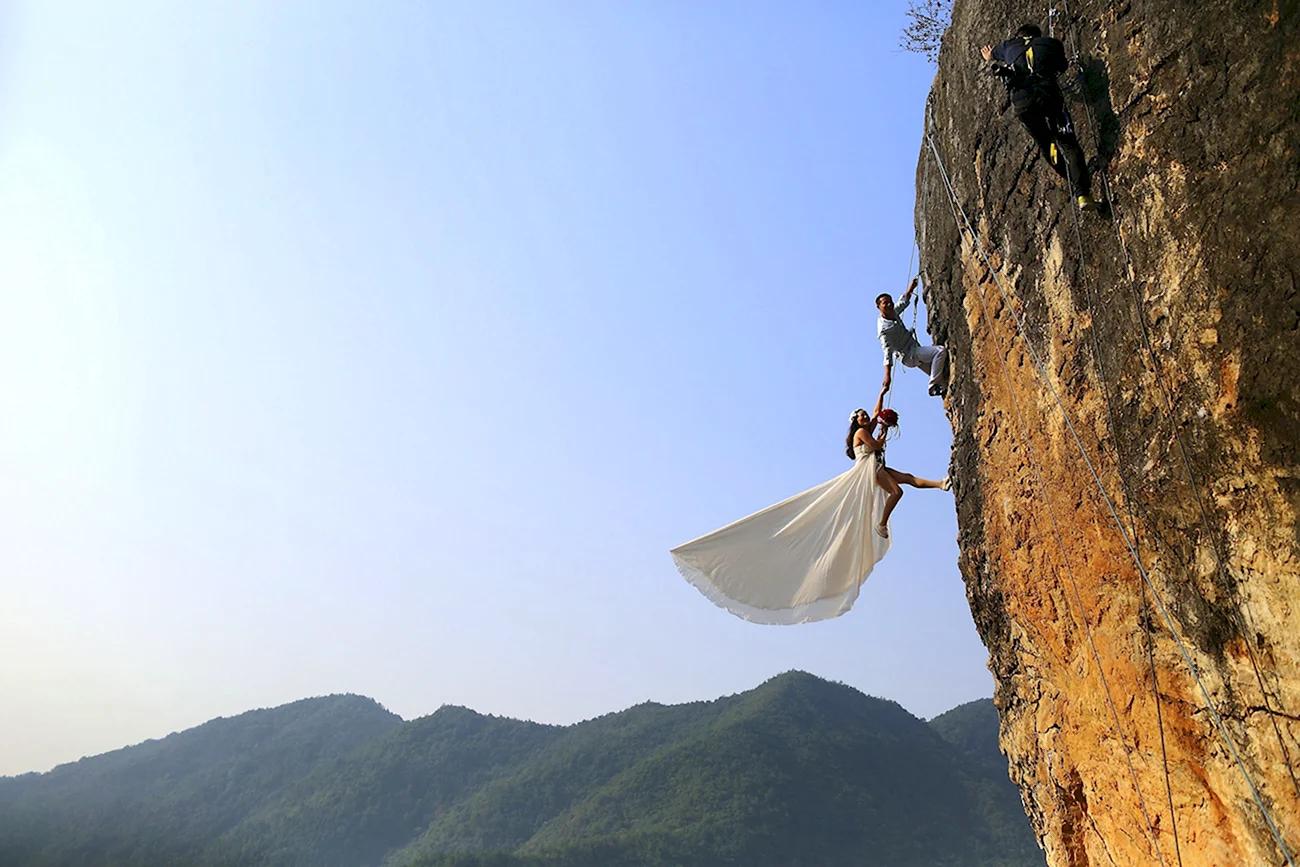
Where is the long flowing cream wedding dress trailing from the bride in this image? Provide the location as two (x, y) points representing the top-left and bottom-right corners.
(671, 445), (889, 624)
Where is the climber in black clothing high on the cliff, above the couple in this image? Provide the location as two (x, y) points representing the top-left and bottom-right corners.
(980, 25), (1101, 211)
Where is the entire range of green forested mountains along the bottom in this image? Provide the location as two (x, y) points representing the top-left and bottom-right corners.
(0, 672), (1043, 867)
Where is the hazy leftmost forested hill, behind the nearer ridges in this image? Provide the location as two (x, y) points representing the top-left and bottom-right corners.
(0, 695), (402, 867)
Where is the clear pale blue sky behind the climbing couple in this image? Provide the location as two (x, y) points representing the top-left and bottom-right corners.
(0, 0), (992, 773)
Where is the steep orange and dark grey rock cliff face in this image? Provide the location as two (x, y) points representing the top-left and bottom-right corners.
(917, 0), (1300, 867)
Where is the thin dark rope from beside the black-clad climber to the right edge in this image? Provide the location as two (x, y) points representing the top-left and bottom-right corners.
(1052, 0), (1300, 797)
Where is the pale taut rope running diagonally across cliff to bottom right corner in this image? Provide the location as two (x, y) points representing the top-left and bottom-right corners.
(926, 118), (1295, 867)
